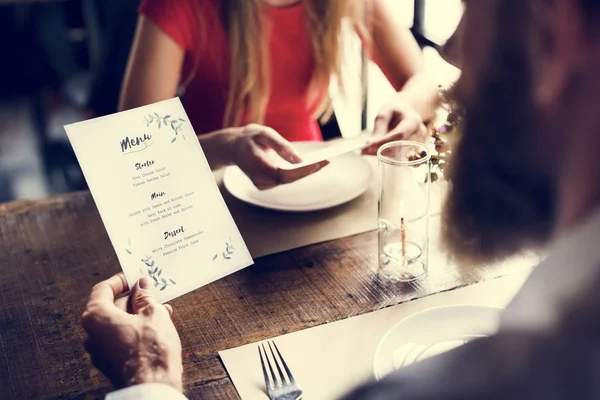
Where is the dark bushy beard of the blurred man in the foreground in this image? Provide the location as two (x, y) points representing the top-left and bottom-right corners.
(442, 6), (555, 265)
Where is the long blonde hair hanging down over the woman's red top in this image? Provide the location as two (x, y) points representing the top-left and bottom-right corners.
(193, 0), (369, 127)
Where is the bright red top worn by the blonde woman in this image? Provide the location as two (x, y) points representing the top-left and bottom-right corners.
(139, 0), (327, 141)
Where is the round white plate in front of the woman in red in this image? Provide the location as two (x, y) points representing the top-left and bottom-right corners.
(223, 142), (373, 211)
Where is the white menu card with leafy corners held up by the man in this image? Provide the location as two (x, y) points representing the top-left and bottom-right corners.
(65, 98), (253, 302)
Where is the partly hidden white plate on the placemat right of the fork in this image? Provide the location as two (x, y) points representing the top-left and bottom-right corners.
(373, 305), (502, 379)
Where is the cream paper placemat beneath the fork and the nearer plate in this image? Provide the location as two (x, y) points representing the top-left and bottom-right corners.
(219, 269), (529, 400)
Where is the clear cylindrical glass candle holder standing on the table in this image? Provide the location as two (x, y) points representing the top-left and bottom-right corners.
(377, 140), (431, 282)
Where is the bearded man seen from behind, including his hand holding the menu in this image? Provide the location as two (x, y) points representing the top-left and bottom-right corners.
(83, 0), (600, 400)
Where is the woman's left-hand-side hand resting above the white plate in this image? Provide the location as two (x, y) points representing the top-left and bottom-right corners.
(229, 124), (328, 190)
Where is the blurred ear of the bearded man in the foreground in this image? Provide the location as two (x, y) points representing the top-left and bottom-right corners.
(524, 0), (585, 108)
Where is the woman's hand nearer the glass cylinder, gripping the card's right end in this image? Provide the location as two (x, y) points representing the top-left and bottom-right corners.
(363, 92), (427, 155)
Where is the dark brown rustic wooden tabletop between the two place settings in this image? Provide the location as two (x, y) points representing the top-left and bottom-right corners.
(0, 192), (524, 399)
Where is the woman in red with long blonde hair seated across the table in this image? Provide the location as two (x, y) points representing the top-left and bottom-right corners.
(120, 0), (437, 189)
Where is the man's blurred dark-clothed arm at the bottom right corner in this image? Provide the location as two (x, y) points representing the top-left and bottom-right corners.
(343, 334), (600, 400)
